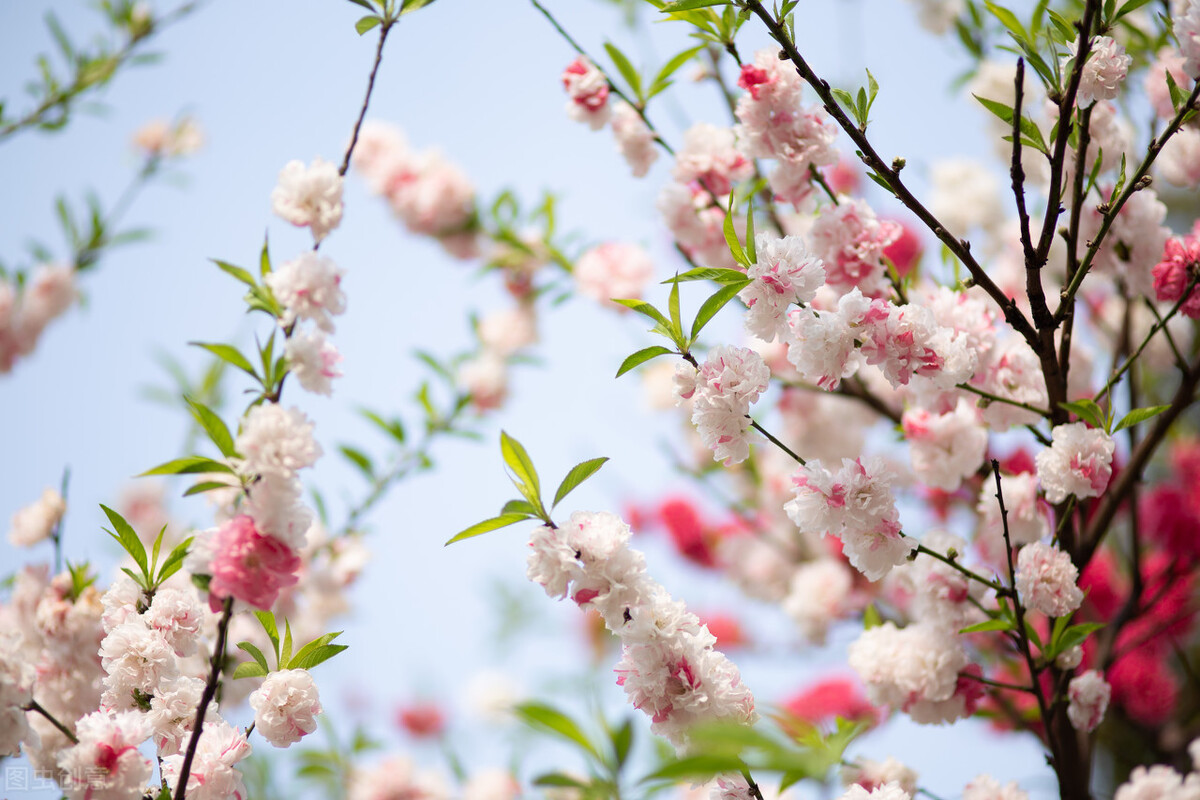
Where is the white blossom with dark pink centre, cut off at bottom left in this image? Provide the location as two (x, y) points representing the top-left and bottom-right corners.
(59, 711), (152, 800)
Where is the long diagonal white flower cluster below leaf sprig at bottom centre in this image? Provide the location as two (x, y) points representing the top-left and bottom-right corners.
(527, 511), (757, 748)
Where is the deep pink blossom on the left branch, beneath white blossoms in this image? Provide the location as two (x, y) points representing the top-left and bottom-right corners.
(209, 515), (300, 610)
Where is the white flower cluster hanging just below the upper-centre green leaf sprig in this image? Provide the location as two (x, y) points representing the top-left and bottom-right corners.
(676, 345), (770, 465)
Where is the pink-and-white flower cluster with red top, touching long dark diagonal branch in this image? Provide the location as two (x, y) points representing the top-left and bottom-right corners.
(736, 48), (838, 206)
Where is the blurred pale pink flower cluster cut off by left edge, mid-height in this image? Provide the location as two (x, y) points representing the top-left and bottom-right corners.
(0, 264), (79, 374)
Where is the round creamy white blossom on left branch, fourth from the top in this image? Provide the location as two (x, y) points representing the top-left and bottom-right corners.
(234, 403), (322, 480)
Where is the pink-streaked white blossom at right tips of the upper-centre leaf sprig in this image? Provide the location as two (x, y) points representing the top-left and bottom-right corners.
(738, 233), (824, 342)
